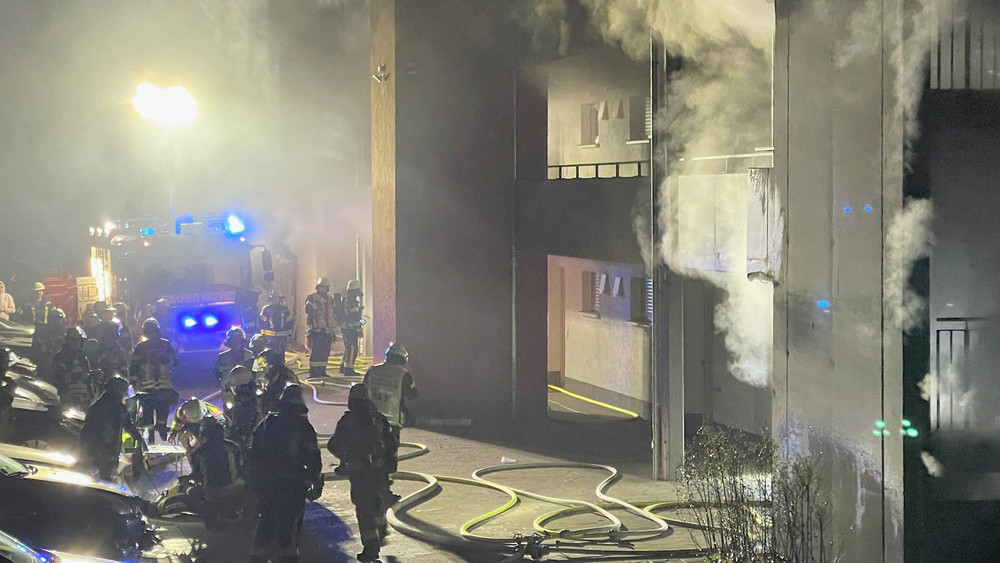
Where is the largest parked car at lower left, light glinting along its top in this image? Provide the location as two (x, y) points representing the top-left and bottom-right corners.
(0, 455), (159, 561)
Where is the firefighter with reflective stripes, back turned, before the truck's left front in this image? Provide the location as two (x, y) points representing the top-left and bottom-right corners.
(128, 318), (179, 443)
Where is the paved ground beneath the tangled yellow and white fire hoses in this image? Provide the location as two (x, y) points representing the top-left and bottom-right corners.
(152, 378), (701, 563)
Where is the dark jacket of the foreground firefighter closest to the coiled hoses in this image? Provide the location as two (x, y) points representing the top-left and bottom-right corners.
(326, 404), (399, 475)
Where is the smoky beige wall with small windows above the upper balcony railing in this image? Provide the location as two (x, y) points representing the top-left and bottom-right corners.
(543, 51), (649, 165)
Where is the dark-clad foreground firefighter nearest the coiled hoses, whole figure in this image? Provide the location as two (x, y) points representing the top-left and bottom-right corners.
(326, 383), (399, 563)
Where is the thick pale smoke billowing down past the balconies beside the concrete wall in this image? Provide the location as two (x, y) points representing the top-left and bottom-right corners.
(583, 0), (780, 387)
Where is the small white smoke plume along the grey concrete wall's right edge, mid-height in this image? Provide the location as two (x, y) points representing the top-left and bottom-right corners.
(882, 199), (934, 332)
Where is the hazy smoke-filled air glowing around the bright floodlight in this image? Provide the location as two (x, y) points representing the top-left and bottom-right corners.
(0, 0), (369, 275)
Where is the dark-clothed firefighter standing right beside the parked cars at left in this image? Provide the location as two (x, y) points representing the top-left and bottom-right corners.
(80, 376), (142, 480)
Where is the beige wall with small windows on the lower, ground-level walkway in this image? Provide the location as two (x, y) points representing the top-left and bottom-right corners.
(549, 256), (650, 419)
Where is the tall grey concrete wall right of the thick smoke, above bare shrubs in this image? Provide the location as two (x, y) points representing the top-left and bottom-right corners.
(773, 0), (903, 561)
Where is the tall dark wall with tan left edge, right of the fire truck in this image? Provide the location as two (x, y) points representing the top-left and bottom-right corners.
(371, 0), (514, 423)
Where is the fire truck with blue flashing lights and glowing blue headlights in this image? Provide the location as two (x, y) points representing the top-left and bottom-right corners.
(89, 214), (271, 353)
